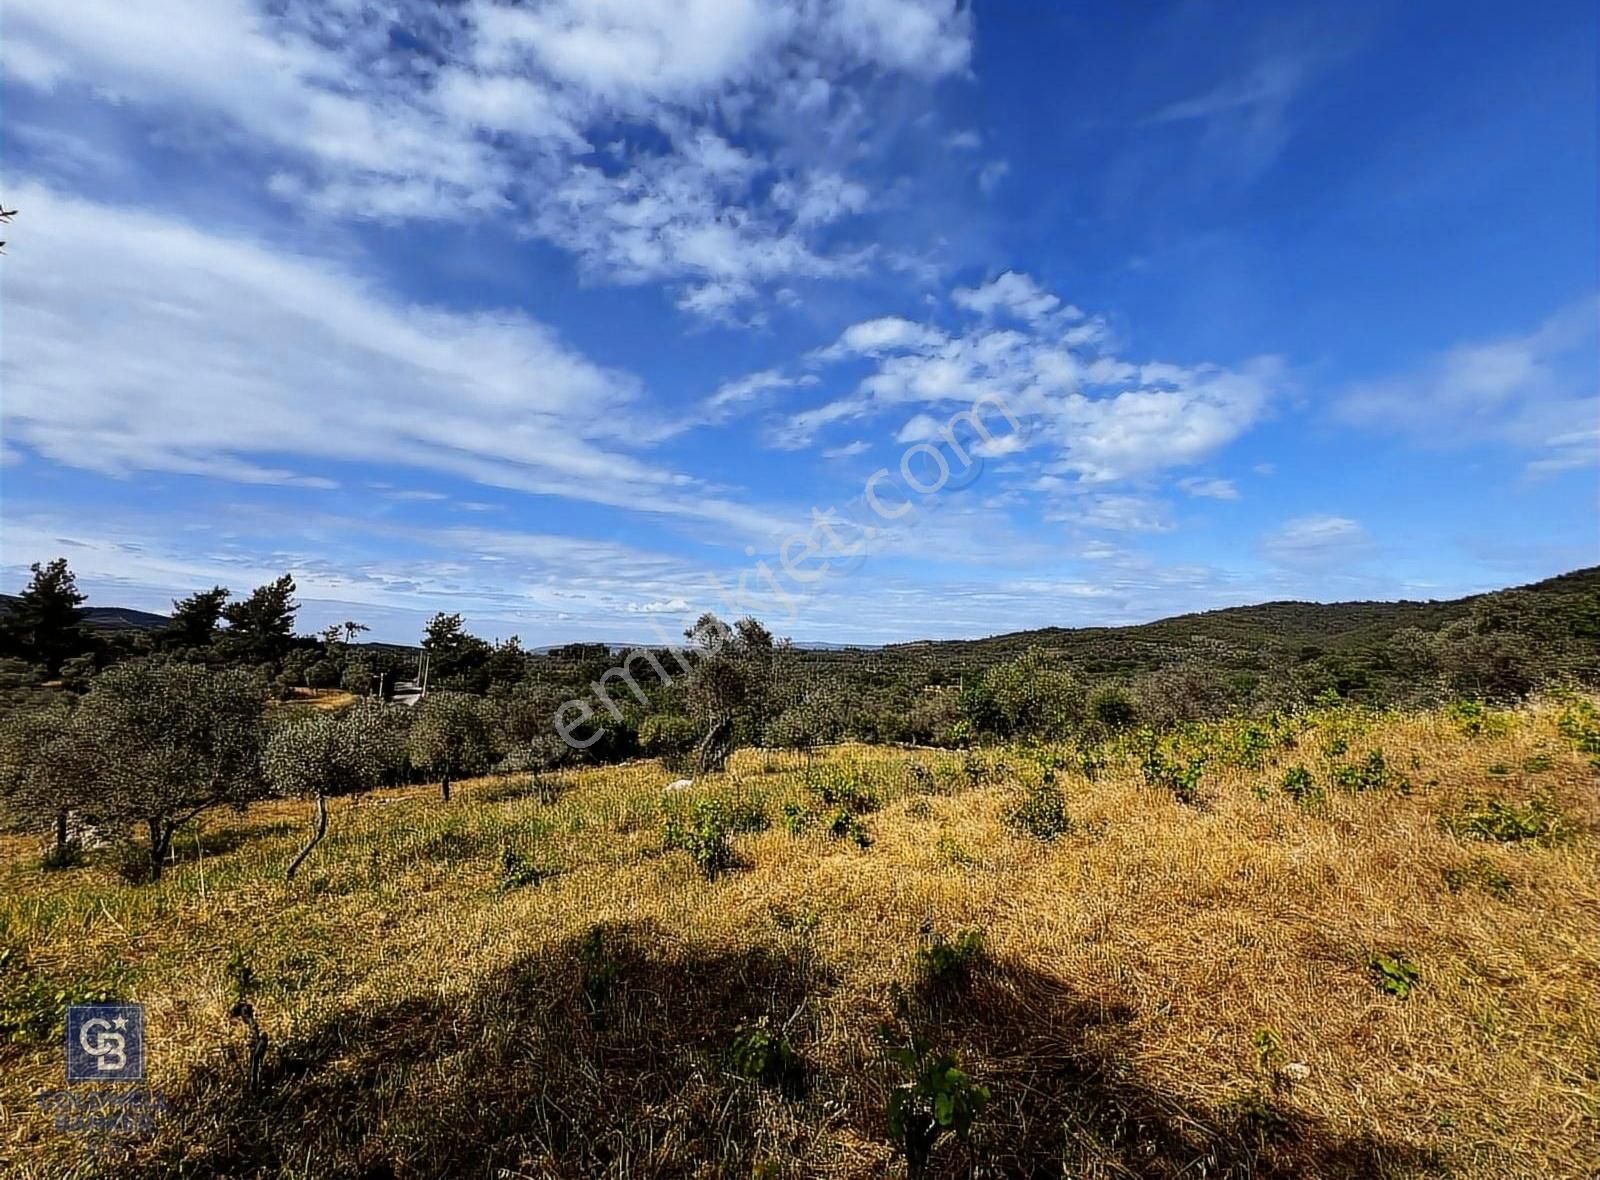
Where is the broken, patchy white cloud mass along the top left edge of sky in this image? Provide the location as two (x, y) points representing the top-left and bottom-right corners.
(3, 0), (971, 323)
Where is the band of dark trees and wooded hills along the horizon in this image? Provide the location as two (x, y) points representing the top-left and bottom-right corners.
(0, 560), (1600, 764)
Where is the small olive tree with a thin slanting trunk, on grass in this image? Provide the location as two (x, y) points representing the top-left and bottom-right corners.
(262, 702), (405, 879)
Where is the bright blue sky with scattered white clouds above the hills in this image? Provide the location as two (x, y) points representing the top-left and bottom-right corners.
(0, 0), (1600, 644)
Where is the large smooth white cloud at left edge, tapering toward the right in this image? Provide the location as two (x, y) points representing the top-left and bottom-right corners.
(0, 182), (800, 532)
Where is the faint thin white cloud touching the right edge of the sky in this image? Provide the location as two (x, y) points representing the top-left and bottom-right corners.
(1334, 297), (1600, 475)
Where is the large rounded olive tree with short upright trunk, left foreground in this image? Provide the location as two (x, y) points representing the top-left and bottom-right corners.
(72, 662), (266, 879)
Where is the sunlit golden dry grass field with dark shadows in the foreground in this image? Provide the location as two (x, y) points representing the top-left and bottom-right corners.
(0, 700), (1600, 1180)
